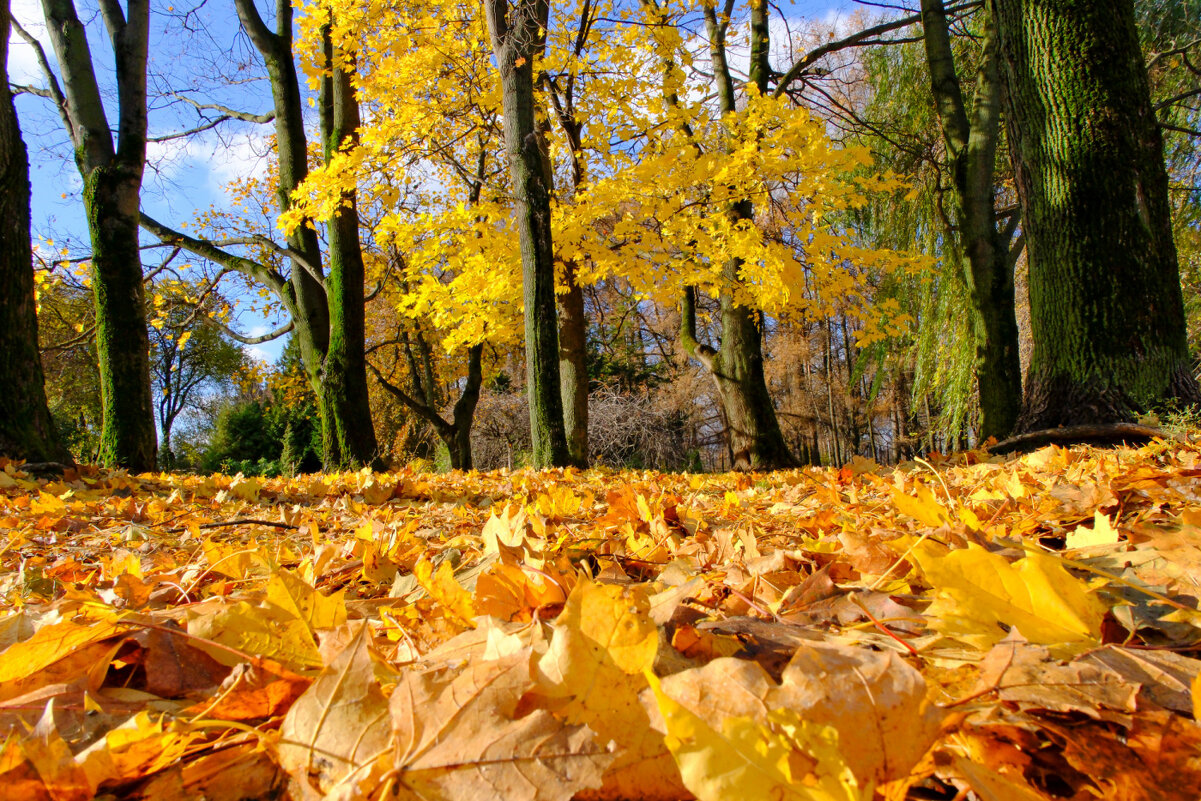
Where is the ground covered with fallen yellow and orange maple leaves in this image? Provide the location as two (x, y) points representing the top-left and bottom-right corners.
(0, 441), (1201, 801)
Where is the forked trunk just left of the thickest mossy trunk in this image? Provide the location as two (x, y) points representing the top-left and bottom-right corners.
(921, 0), (1022, 441)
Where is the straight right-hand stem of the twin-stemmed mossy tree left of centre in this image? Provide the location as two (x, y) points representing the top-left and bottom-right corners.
(322, 28), (378, 467)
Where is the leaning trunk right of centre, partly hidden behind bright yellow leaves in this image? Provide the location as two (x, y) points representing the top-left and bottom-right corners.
(681, 2), (796, 471)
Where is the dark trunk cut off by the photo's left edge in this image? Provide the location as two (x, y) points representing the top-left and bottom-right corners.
(0, 0), (71, 464)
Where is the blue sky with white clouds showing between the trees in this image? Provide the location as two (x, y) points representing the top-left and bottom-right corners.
(8, 0), (879, 360)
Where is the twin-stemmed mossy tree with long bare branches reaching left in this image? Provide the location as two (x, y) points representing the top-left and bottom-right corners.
(142, 0), (380, 470)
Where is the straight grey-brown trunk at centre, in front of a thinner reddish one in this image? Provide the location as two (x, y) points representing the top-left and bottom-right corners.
(484, 0), (570, 467)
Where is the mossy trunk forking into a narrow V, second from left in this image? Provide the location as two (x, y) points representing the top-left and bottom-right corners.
(42, 0), (157, 472)
